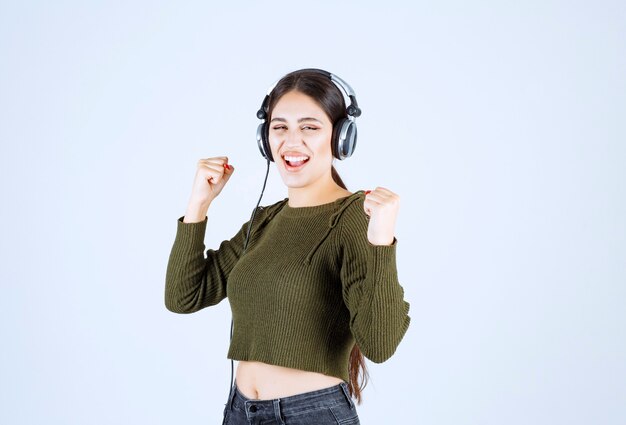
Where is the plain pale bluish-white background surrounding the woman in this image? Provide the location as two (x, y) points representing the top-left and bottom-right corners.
(0, 1), (626, 425)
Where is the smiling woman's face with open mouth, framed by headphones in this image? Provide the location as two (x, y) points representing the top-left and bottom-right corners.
(269, 90), (333, 188)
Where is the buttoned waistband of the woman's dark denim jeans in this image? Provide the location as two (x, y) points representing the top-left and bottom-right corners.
(229, 381), (354, 415)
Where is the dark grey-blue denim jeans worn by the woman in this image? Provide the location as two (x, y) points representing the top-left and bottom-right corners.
(222, 381), (360, 425)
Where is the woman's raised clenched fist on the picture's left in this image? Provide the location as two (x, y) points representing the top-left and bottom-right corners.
(189, 156), (235, 207)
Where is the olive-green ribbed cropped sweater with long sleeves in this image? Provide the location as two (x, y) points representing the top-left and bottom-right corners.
(165, 191), (410, 382)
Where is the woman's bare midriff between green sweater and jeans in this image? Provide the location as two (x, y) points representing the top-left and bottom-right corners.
(235, 360), (343, 400)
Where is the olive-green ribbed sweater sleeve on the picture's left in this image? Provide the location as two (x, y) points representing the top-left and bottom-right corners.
(165, 217), (257, 313)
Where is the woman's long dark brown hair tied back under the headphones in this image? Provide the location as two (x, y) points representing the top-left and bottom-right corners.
(267, 70), (369, 404)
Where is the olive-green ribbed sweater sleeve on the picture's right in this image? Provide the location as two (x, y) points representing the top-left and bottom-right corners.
(339, 199), (411, 363)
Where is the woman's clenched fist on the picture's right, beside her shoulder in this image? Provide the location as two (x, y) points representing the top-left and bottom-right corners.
(363, 186), (400, 245)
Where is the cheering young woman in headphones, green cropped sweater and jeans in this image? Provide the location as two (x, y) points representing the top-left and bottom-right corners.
(165, 69), (410, 425)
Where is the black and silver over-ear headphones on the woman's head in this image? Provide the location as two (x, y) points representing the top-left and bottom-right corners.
(256, 68), (361, 161)
